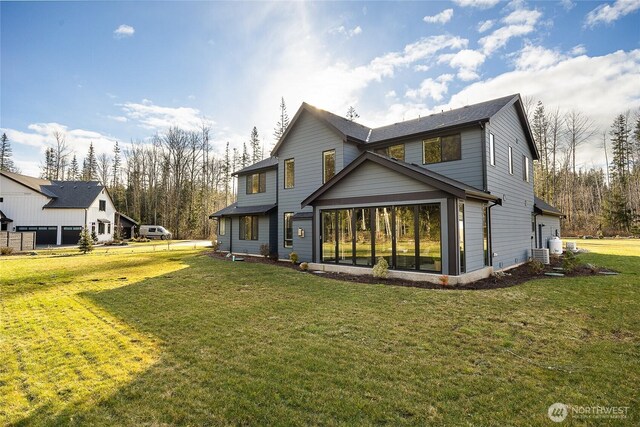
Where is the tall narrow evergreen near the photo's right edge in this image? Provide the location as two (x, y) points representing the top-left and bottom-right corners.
(608, 114), (634, 231)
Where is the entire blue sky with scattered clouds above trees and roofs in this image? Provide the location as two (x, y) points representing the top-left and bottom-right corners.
(0, 0), (640, 174)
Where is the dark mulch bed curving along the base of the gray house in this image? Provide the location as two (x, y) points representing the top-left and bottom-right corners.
(209, 252), (613, 290)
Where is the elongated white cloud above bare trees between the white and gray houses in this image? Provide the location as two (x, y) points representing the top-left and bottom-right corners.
(118, 99), (211, 131)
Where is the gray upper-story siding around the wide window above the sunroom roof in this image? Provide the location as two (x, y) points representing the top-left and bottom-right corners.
(404, 127), (483, 189)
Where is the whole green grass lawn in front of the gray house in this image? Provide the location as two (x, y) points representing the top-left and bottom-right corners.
(0, 240), (640, 426)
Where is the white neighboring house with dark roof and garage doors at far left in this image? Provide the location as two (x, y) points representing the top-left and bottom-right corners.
(0, 171), (116, 245)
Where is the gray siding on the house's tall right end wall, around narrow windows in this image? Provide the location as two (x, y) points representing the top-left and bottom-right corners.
(485, 105), (533, 269)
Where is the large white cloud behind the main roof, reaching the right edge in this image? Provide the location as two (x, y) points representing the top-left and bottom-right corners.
(436, 49), (640, 165)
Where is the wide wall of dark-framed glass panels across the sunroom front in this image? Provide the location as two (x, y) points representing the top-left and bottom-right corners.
(320, 203), (442, 273)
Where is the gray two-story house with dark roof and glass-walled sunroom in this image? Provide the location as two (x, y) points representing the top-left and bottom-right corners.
(211, 95), (562, 283)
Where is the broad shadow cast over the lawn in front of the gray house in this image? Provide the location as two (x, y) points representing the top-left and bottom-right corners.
(11, 252), (638, 425)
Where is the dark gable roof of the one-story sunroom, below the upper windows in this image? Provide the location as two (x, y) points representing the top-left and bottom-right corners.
(301, 151), (498, 208)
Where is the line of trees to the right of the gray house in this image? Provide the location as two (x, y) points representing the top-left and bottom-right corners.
(525, 99), (640, 236)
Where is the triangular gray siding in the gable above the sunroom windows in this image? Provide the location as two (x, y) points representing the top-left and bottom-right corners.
(319, 161), (435, 200)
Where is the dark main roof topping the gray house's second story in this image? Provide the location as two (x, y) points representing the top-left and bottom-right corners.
(271, 94), (539, 160)
